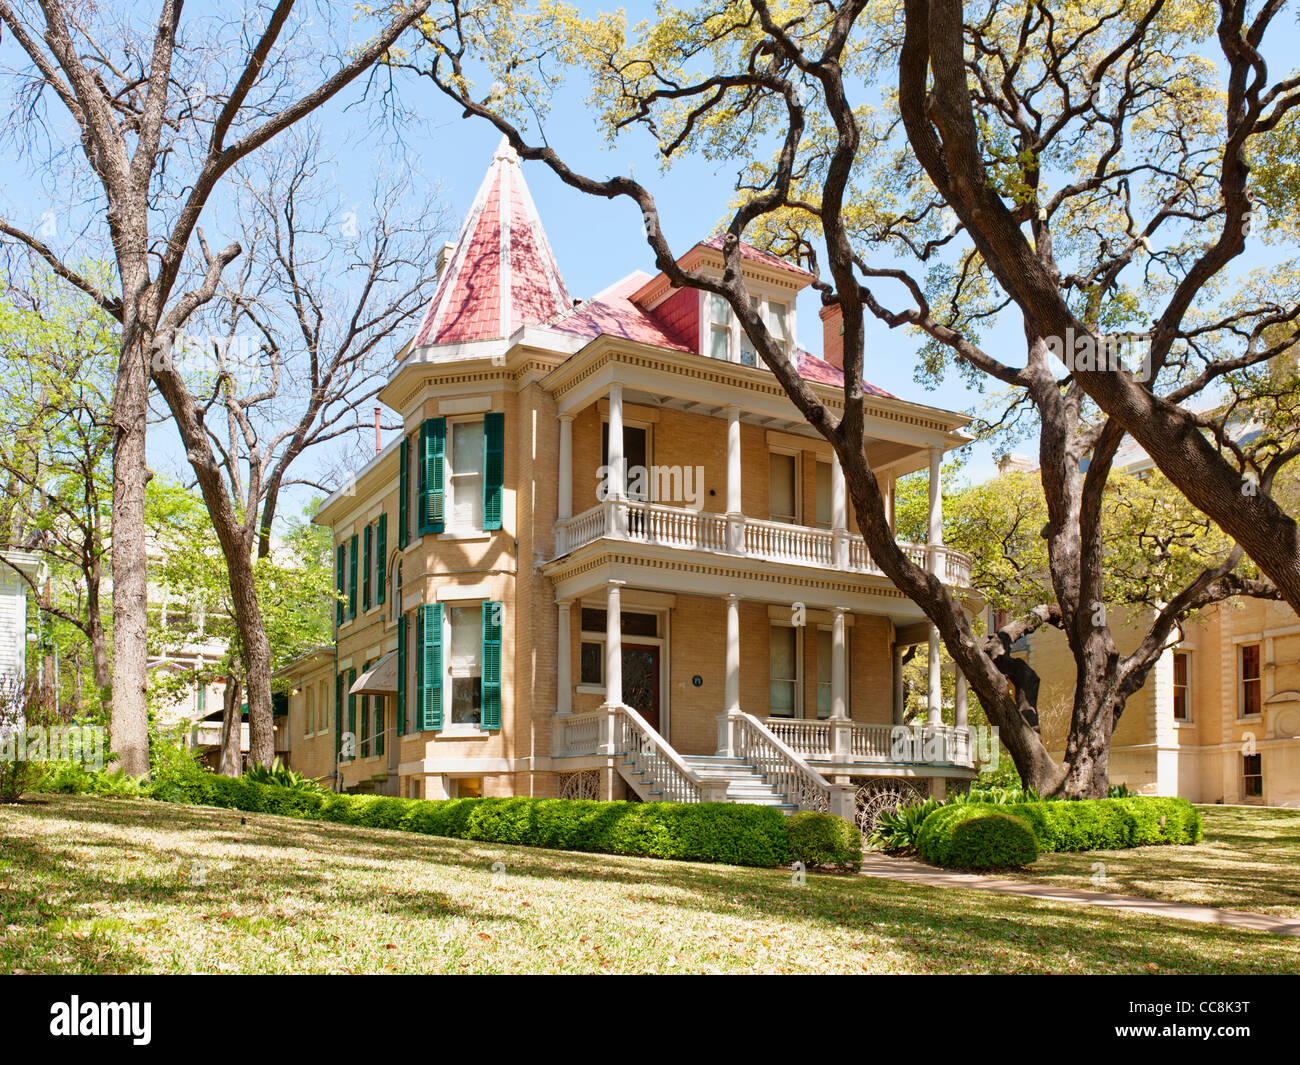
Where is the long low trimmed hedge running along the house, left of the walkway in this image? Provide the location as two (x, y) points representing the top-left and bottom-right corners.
(153, 774), (793, 866)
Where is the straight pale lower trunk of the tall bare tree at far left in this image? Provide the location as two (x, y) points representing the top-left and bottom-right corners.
(111, 328), (150, 776)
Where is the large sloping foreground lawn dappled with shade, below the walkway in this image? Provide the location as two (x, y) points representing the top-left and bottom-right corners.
(0, 796), (1300, 973)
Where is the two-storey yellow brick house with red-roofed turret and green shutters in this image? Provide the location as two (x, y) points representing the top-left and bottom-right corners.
(283, 139), (982, 815)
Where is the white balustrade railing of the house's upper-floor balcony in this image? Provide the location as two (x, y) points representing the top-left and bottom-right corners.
(555, 499), (971, 586)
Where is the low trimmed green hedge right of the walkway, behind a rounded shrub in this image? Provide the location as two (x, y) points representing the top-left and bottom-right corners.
(917, 797), (1204, 869)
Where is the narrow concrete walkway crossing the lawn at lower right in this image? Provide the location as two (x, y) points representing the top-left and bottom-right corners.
(862, 850), (1300, 936)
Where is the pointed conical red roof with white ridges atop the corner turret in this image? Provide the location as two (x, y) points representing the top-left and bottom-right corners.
(415, 139), (571, 347)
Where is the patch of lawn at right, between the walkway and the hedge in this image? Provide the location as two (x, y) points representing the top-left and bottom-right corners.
(1010, 806), (1300, 917)
